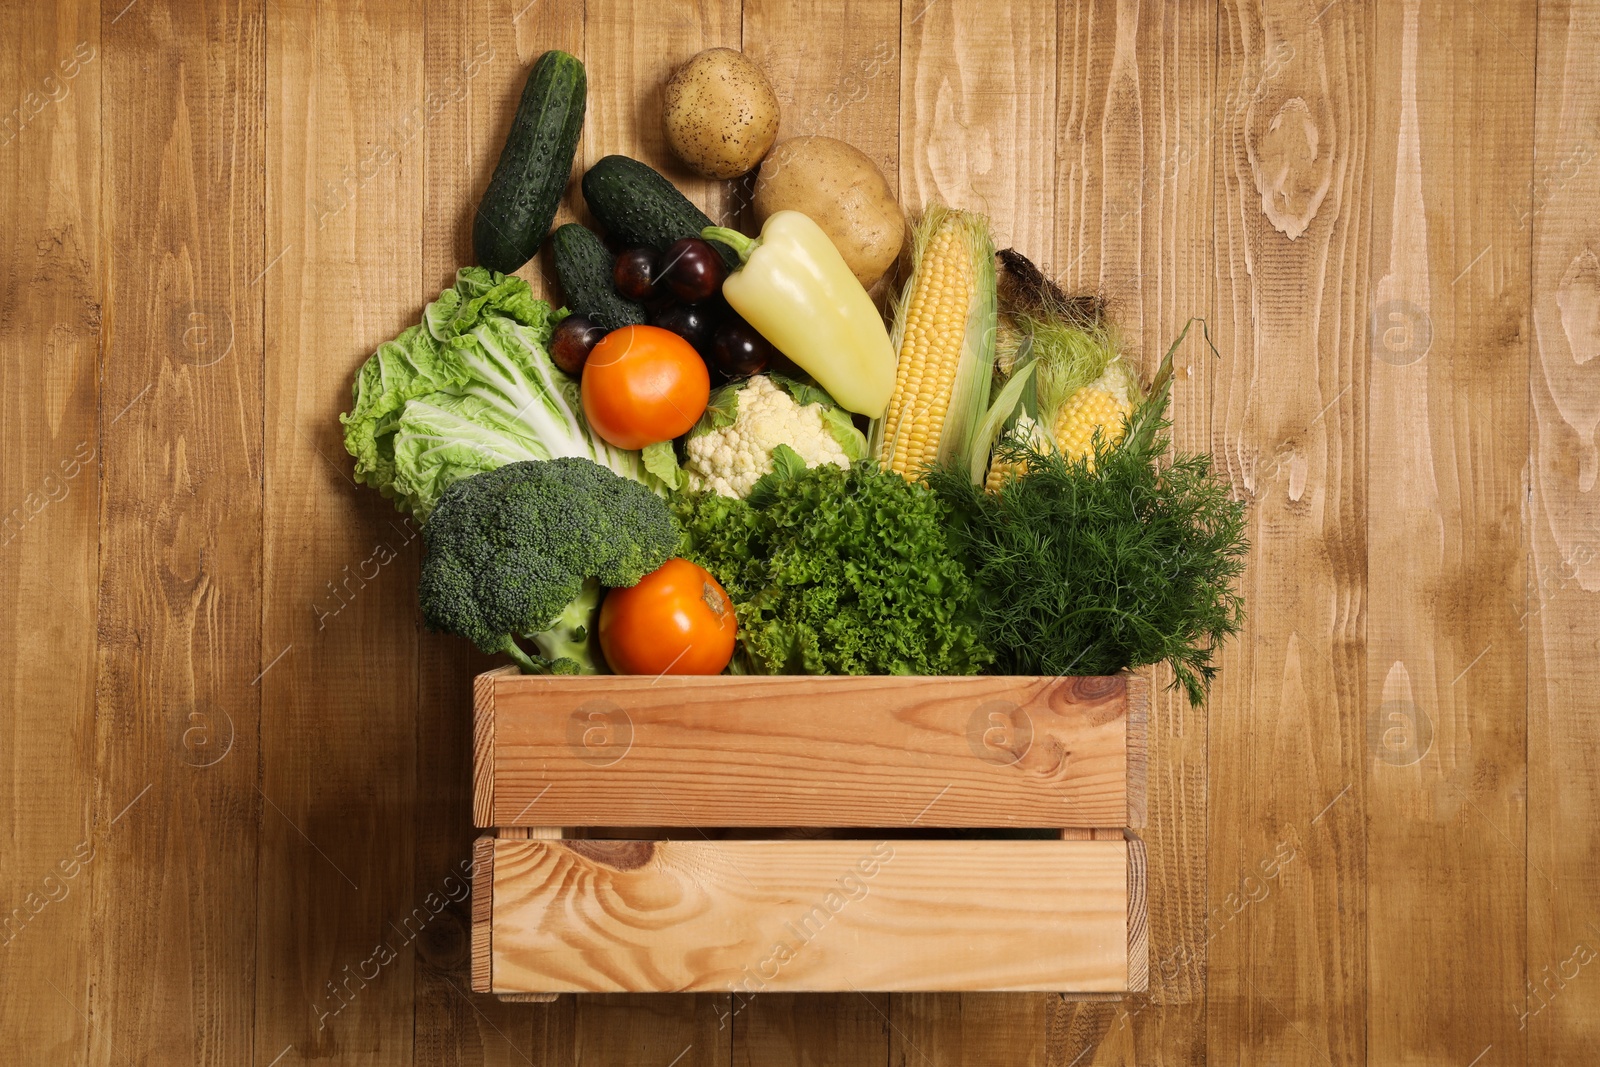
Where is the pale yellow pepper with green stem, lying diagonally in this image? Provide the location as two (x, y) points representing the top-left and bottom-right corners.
(701, 211), (894, 419)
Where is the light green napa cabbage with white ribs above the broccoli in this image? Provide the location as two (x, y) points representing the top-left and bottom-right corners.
(341, 267), (650, 518)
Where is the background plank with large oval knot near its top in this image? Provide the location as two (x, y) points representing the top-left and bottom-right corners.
(1216, 3), (1369, 1064)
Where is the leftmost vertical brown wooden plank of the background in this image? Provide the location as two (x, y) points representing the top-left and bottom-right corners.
(0, 3), (100, 1062)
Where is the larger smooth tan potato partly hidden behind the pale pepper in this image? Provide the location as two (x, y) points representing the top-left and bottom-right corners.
(755, 138), (906, 290)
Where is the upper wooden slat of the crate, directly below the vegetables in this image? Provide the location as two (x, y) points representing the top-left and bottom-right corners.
(477, 673), (1130, 827)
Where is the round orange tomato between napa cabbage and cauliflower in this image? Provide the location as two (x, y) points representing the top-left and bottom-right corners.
(582, 326), (710, 448)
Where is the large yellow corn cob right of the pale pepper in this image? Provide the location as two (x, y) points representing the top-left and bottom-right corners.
(872, 205), (995, 482)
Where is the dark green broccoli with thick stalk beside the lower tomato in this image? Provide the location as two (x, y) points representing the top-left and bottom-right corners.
(419, 458), (678, 673)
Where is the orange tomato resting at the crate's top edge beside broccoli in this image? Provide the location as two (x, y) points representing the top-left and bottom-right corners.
(600, 560), (738, 675)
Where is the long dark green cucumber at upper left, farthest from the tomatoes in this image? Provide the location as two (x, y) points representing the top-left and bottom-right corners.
(472, 50), (587, 274)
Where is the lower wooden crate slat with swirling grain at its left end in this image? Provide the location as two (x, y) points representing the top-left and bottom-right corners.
(474, 838), (1147, 993)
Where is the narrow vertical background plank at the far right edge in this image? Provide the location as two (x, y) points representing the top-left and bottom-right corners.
(1523, 3), (1600, 1064)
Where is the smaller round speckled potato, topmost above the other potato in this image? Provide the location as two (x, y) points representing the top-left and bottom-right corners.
(662, 48), (778, 178)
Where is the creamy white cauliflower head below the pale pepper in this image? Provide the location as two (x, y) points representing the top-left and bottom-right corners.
(683, 374), (867, 499)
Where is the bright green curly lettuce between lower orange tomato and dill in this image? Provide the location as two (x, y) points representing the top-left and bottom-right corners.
(672, 460), (994, 675)
